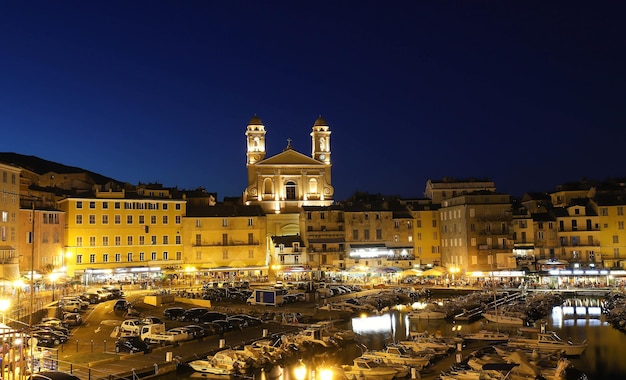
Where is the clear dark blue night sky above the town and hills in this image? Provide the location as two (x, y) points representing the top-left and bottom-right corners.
(0, 0), (626, 199)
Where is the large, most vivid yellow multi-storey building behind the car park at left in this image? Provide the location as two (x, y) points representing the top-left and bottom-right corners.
(59, 185), (186, 285)
